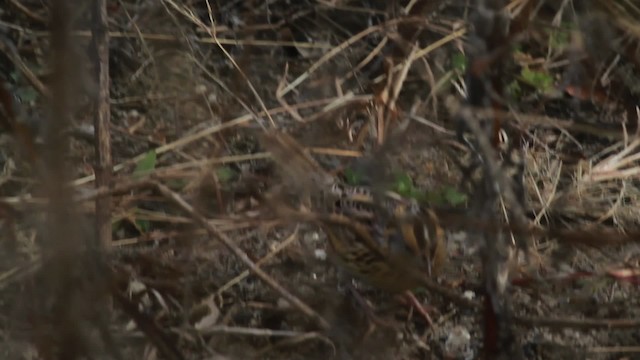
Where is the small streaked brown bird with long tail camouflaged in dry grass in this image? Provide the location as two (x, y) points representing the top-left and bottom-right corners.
(260, 130), (447, 323)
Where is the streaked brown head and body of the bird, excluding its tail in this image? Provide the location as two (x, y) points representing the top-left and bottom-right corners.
(321, 183), (446, 293)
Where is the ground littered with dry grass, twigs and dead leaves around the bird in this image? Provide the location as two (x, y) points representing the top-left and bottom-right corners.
(0, 0), (640, 359)
